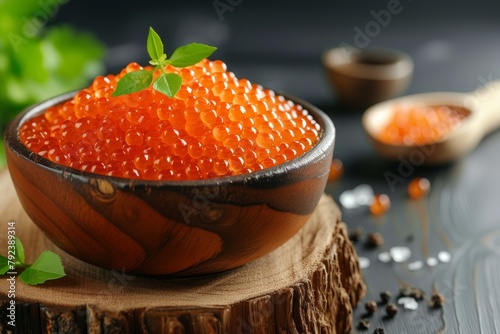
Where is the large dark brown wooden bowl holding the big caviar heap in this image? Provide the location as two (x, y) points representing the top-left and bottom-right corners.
(5, 92), (335, 276)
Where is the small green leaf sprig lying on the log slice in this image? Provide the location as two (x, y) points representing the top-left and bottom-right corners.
(0, 237), (66, 285)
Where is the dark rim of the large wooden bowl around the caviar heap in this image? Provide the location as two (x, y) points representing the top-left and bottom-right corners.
(4, 89), (336, 187)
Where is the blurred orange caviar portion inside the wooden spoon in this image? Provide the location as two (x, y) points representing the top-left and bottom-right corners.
(378, 105), (470, 145)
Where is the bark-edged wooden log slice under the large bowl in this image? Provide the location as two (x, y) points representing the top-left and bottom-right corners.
(0, 171), (365, 334)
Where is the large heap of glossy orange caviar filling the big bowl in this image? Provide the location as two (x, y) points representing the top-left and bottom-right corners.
(19, 59), (321, 180)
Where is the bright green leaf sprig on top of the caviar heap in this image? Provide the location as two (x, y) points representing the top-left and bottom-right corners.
(113, 27), (217, 98)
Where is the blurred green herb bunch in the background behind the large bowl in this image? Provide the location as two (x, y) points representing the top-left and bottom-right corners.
(0, 0), (104, 168)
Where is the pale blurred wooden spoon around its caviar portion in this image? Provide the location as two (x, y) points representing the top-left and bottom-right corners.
(362, 81), (500, 166)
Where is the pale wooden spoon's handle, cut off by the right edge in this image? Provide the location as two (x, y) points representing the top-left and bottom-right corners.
(470, 81), (500, 135)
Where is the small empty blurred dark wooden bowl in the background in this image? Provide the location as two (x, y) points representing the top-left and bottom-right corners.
(323, 47), (413, 107)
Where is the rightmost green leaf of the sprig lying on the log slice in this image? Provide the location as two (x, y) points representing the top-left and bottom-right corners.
(19, 251), (66, 285)
